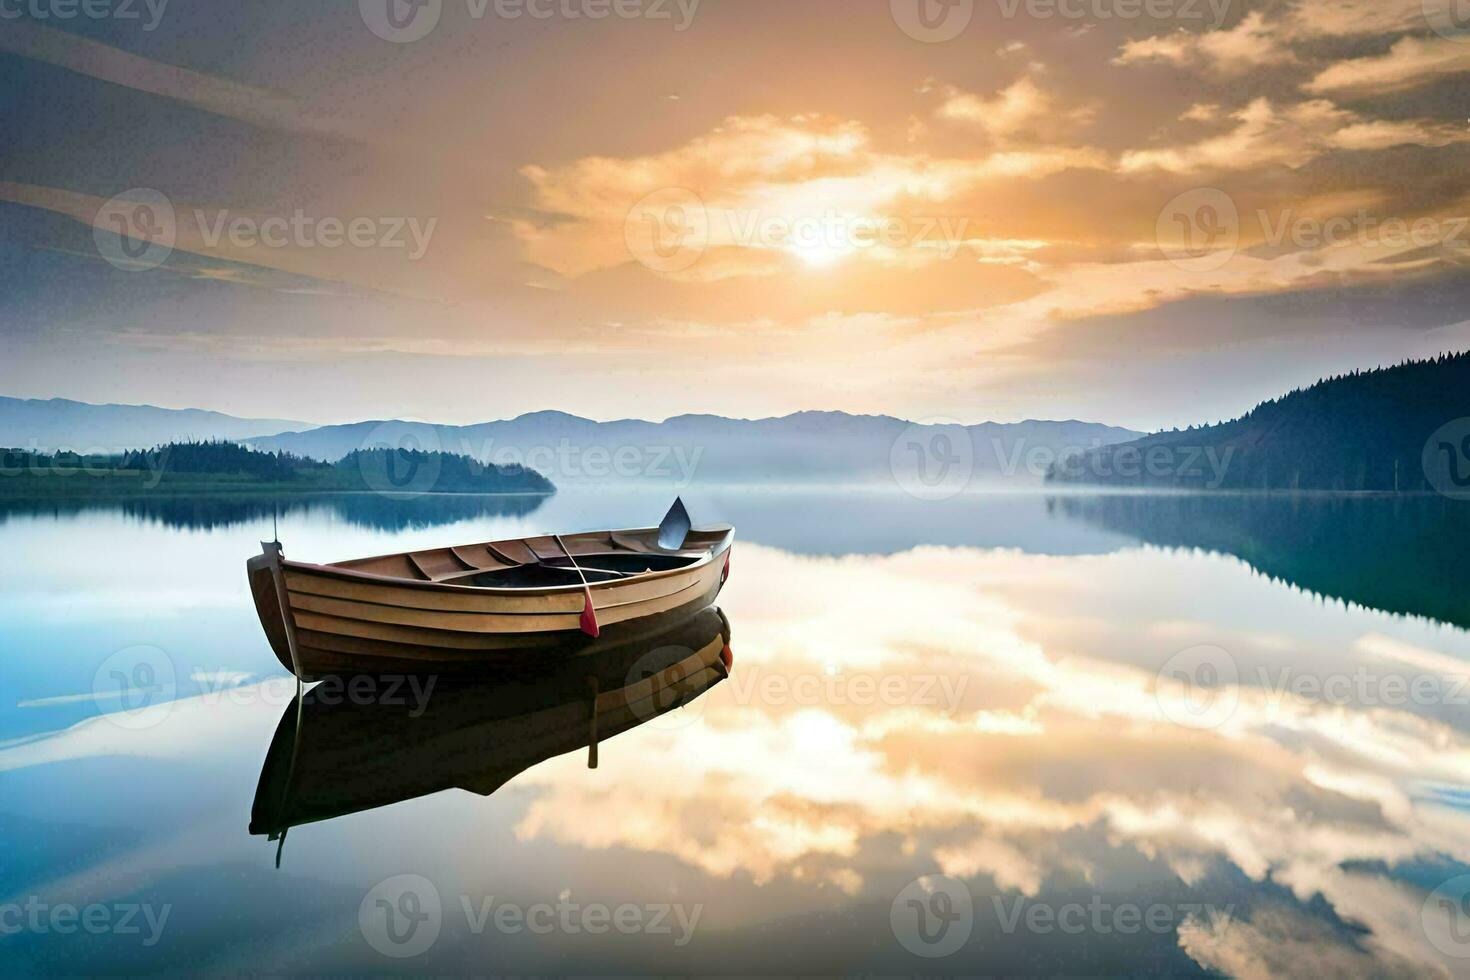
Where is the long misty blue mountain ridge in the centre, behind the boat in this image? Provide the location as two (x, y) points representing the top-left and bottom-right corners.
(250, 411), (1142, 492)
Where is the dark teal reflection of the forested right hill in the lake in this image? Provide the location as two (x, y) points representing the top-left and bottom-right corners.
(1048, 494), (1470, 627)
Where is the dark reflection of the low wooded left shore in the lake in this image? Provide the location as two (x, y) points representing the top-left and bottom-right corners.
(0, 494), (547, 530)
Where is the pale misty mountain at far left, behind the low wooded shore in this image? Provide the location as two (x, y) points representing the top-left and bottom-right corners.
(0, 397), (309, 453)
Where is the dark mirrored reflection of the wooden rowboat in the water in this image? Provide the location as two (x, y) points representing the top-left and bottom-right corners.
(250, 607), (729, 864)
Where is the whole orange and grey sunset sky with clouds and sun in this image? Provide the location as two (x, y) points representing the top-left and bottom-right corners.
(0, 0), (1470, 428)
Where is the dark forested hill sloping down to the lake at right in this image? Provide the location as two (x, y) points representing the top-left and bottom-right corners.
(1047, 353), (1470, 497)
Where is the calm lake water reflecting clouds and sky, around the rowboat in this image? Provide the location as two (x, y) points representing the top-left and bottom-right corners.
(0, 489), (1470, 977)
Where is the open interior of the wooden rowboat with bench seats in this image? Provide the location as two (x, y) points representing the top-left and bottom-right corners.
(326, 527), (729, 589)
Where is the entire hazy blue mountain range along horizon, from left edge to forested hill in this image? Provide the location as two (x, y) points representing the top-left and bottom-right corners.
(0, 398), (1144, 492)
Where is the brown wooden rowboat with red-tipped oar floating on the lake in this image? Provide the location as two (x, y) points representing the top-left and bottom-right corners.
(245, 501), (735, 680)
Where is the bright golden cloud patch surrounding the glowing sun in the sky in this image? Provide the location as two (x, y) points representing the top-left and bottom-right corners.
(512, 117), (1110, 282)
